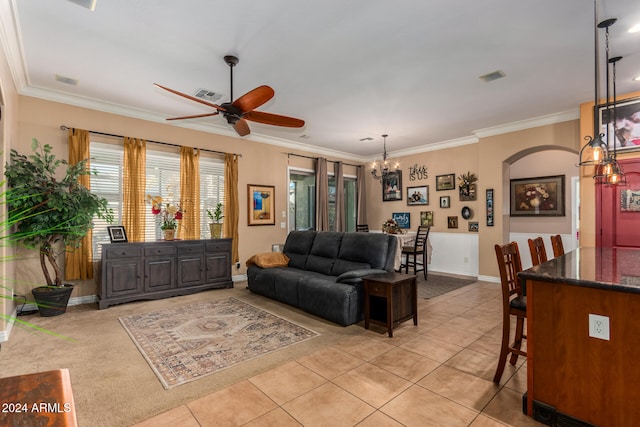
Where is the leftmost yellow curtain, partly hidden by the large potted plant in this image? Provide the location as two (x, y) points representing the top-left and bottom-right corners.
(64, 129), (93, 280)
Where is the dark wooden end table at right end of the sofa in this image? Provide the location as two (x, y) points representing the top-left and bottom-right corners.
(362, 272), (418, 338)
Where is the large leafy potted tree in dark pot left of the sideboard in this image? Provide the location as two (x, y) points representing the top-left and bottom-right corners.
(4, 139), (113, 316)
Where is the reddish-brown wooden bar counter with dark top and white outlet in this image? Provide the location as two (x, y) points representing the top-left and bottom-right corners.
(519, 248), (640, 427)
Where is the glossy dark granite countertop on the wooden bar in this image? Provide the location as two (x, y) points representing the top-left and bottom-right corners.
(518, 248), (640, 293)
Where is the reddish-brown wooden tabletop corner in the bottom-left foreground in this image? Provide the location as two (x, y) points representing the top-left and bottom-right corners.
(0, 369), (78, 427)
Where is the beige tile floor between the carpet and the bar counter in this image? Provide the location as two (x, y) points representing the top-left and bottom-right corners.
(137, 282), (541, 427)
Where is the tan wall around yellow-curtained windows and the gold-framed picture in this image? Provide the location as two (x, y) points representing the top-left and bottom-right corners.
(13, 97), (357, 297)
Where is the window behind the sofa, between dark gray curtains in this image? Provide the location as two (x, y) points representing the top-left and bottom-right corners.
(289, 169), (357, 231)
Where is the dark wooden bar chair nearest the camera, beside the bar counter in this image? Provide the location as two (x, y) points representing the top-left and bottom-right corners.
(493, 242), (527, 384)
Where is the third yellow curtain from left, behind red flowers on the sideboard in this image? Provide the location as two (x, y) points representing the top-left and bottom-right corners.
(178, 147), (200, 240)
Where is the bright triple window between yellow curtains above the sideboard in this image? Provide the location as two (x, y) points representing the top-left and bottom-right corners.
(90, 142), (224, 258)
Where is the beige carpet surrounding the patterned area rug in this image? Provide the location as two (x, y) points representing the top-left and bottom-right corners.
(0, 282), (364, 427)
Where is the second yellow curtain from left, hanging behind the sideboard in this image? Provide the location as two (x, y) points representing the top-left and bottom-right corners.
(122, 136), (150, 242)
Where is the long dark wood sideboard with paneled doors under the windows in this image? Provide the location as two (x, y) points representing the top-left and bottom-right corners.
(98, 239), (233, 309)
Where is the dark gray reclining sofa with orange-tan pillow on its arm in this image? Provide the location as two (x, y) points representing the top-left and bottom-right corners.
(247, 231), (397, 326)
